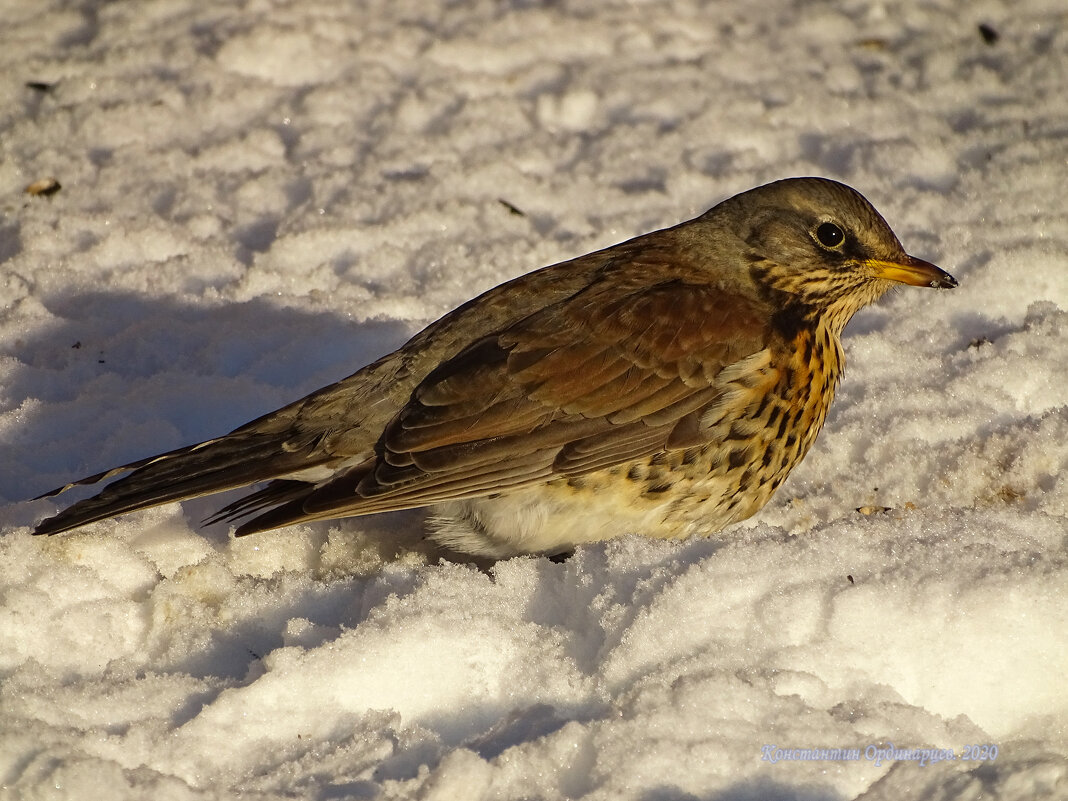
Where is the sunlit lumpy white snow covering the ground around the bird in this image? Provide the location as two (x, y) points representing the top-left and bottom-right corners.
(0, 0), (1068, 801)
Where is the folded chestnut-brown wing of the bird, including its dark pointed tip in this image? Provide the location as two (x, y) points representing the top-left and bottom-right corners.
(239, 270), (767, 534)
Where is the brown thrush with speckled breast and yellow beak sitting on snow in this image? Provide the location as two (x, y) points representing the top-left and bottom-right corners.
(34, 177), (957, 560)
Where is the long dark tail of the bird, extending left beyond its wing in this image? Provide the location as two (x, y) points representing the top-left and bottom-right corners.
(33, 435), (328, 534)
